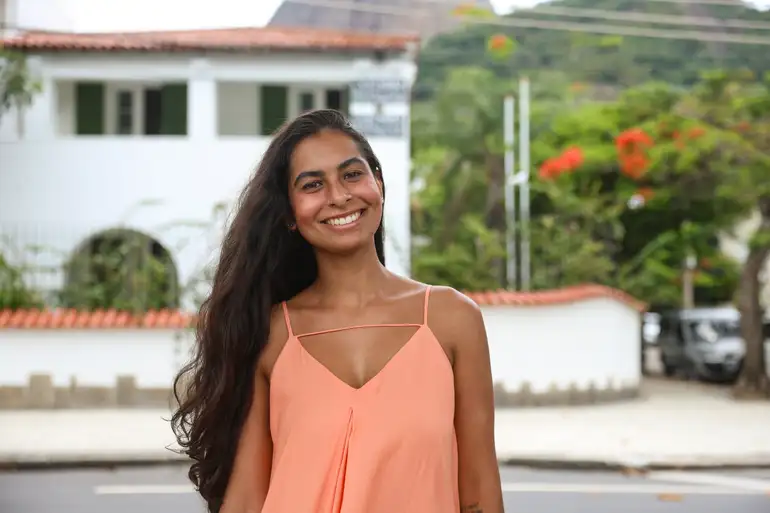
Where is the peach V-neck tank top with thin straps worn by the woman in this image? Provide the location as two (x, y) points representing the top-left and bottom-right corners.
(262, 288), (460, 513)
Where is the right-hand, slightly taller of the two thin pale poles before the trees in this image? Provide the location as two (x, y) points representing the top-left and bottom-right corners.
(519, 77), (532, 291)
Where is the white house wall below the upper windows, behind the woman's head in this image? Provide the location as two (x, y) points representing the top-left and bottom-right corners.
(0, 136), (409, 288)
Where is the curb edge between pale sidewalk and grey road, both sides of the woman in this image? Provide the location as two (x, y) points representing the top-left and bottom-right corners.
(0, 450), (770, 473)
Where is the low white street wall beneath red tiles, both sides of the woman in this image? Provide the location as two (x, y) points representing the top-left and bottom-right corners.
(0, 298), (641, 393)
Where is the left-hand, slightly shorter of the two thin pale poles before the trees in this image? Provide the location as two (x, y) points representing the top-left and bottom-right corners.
(503, 94), (517, 290)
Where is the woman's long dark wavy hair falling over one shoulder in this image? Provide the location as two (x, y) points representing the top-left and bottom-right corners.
(171, 110), (385, 513)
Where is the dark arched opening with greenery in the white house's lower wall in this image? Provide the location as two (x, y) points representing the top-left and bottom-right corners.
(60, 229), (180, 312)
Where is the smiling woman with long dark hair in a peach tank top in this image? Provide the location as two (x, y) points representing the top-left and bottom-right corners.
(173, 110), (503, 513)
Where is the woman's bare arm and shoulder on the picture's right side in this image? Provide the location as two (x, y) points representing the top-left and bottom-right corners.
(431, 287), (503, 513)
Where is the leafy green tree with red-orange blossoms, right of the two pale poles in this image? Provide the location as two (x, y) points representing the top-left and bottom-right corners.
(533, 77), (770, 306)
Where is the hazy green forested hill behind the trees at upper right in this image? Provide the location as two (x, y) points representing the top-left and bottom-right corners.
(415, 0), (770, 99)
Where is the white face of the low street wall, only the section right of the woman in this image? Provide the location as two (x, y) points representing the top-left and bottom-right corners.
(483, 298), (641, 392)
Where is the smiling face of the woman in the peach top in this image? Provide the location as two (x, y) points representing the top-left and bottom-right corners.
(289, 130), (383, 253)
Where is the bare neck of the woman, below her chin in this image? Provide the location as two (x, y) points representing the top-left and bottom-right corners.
(313, 245), (390, 307)
